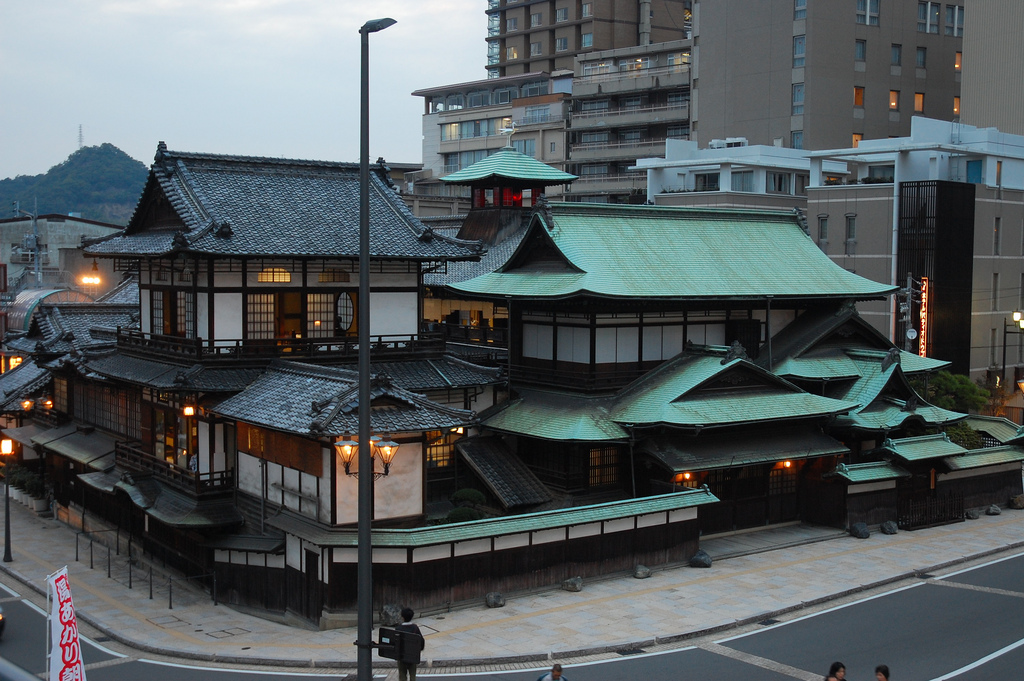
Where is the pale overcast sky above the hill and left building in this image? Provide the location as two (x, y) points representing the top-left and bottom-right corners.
(0, 0), (486, 178)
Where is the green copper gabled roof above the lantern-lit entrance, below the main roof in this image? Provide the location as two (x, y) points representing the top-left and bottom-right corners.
(611, 356), (857, 426)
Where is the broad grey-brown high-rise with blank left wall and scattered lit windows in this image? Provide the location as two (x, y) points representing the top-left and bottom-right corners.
(691, 0), (965, 148)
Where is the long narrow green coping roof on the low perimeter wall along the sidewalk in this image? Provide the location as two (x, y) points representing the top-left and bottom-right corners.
(267, 487), (719, 548)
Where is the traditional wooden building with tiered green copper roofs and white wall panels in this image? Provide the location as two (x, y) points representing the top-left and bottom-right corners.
(449, 204), (964, 531)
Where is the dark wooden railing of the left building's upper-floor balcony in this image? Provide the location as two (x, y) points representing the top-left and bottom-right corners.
(118, 329), (444, 361)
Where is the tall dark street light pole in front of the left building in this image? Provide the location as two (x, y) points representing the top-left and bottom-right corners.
(355, 14), (395, 681)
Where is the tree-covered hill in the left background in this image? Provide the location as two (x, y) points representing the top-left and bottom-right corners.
(0, 144), (148, 224)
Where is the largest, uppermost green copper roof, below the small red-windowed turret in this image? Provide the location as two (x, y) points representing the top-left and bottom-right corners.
(452, 203), (895, 299)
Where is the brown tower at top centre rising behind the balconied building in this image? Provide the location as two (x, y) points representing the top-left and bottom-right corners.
(486, 0), (692, 78)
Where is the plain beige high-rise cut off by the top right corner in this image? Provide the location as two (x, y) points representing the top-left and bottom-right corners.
(961, 0), (1024, 135)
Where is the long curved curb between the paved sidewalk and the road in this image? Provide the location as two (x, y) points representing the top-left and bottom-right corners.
(6, 528), (1024, 670)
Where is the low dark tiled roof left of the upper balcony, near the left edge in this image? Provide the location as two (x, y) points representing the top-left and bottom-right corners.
(5, 300), (139, 354)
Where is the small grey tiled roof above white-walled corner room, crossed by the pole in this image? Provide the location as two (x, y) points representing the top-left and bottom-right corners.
(212, 360), (474, 436)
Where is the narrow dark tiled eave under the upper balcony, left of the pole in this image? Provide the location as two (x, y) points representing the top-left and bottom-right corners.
(85, 351), (262, 392)
